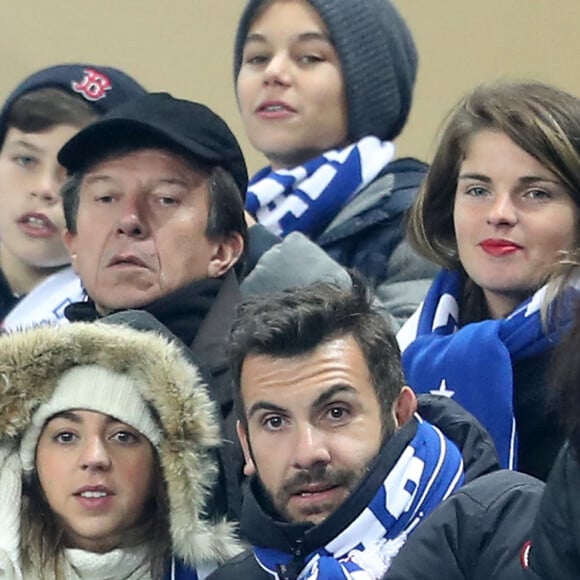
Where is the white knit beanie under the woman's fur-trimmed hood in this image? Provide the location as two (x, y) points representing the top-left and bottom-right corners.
(20, 365), (161, 473)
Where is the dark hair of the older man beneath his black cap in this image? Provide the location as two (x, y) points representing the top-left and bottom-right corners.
(61, 142), (248, 275)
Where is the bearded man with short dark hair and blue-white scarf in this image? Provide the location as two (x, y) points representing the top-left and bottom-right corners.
(210, 279), (542, 580)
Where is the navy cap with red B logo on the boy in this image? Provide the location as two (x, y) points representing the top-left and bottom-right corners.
(0, 63), (146, 144)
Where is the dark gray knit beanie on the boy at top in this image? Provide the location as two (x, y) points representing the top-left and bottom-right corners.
(234, 0), (417, 141)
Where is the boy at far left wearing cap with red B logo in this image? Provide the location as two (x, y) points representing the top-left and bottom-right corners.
(0, 64), (145, 328)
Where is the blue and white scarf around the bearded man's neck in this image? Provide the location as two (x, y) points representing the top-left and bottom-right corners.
(252, 415), (464, 580)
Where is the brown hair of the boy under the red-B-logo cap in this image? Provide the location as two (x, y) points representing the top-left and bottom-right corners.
(6, 88), (99, 144)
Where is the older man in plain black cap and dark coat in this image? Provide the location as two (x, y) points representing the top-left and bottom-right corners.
(58, 93), (247, 518)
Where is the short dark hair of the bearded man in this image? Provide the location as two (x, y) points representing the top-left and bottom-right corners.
(228, 274), (405, 433)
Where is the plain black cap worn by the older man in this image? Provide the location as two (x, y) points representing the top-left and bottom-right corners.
(58, 93), (248, 197)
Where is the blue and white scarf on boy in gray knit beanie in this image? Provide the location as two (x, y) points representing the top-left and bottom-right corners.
(246, 137), (395, 237)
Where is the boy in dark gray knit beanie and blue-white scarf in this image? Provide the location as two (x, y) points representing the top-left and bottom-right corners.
(234, 0), (435, 325)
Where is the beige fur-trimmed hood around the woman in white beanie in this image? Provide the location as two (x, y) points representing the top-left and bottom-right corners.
(0, 322), (238, 566)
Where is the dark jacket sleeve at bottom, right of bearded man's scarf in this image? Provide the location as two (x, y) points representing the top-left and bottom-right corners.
(384, 471), (544, 580)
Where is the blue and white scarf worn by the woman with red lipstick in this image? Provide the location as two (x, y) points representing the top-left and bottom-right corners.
(403, 270), (578, 469)
